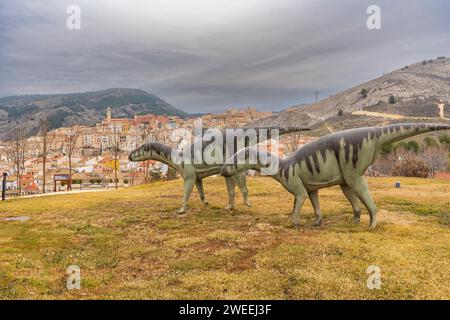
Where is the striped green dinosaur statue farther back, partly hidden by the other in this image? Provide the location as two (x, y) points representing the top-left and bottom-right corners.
(128, 127), (309, 214)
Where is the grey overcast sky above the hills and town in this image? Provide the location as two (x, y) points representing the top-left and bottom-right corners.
(0, 0), (450, 112)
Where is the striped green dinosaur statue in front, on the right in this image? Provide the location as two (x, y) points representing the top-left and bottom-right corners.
(221, 123), (450, 228)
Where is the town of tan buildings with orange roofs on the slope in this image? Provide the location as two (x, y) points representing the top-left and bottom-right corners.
(0, 107), (316, 195)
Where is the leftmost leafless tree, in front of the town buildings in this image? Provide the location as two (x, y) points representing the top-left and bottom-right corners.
(5, 129), (29, 195)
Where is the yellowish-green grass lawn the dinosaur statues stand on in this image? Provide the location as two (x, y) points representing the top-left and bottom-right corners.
(0, 178), (450, 299)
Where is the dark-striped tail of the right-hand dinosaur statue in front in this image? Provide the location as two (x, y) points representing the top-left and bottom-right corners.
(371, 123), (450, 147)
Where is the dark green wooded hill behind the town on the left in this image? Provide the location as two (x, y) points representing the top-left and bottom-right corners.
(0, 88), (187, 138)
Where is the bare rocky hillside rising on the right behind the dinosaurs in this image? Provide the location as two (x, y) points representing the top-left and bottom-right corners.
(256, 57), (450, 130)
